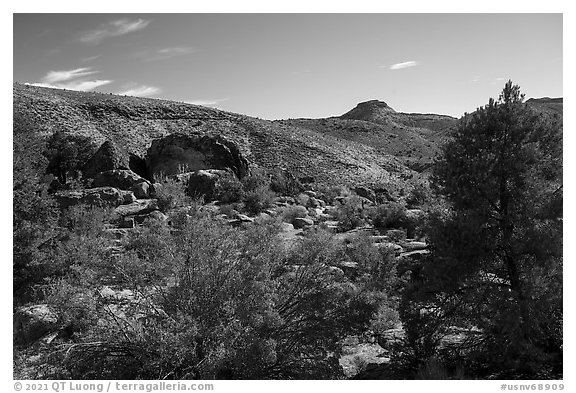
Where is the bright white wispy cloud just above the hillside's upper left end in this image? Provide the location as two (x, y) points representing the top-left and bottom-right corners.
(28, 67), (113, 91)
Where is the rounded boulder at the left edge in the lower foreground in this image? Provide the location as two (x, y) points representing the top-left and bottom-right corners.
(13, 304), (59, 345)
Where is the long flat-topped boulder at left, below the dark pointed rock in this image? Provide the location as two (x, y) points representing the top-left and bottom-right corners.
(54, 187), (124, 209)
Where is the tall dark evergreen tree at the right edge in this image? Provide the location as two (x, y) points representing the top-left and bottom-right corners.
(404, 81), (562, 376)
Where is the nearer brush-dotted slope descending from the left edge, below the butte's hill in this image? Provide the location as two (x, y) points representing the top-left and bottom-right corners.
(13, 84), (428, 193)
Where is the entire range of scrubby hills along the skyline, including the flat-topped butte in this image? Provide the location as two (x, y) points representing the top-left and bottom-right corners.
(13, 83), (562, 189)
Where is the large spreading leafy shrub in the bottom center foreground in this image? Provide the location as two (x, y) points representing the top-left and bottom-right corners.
(40, 218), (376, 379)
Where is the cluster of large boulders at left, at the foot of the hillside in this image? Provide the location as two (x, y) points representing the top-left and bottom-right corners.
(49, 134), (249, 228)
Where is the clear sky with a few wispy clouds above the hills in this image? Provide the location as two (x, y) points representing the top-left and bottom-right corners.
(13, 13), (563, 119)
